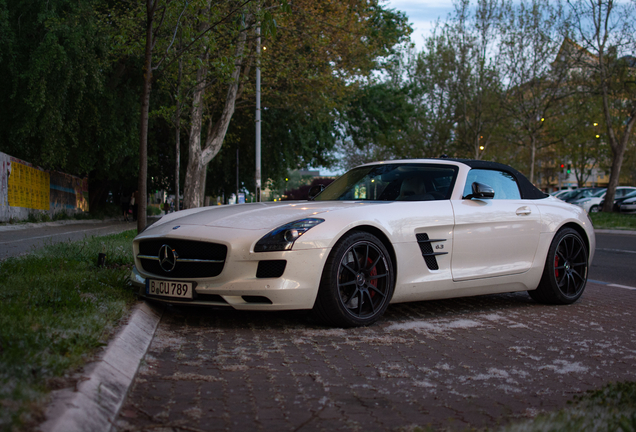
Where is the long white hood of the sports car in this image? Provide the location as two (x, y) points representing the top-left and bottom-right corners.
(153, 201), (387, 230)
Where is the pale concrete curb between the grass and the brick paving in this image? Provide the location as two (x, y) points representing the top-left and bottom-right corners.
(40, 302), (164, 432)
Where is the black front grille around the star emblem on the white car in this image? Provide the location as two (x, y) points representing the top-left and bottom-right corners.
(139, 238), (227, 278)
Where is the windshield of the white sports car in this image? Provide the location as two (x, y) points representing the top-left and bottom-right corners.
(314, 163), (458, 201)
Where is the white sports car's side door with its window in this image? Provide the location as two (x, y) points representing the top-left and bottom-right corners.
(451, 169), (541, 281)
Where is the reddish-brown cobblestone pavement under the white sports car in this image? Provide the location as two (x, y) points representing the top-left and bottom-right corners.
(116, 283), (636, 431)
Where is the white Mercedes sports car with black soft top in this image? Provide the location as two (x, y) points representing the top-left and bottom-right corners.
(131, 159), (595, 327)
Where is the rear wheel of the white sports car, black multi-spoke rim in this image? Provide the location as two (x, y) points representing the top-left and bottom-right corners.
(528, 228), (588, 305)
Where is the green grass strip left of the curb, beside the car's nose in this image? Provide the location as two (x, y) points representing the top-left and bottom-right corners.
(0, 230), (135, 430)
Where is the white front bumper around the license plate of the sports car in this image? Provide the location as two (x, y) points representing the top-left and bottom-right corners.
(130, 249), (330, 310)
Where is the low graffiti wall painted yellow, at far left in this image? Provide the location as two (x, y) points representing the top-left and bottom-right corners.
(0, 152), (88, 222)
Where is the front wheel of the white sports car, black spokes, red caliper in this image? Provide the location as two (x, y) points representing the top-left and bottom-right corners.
(313, 231), (395, 327)
